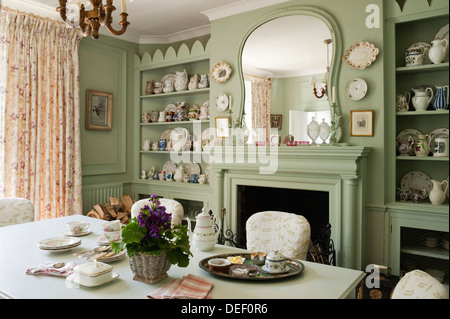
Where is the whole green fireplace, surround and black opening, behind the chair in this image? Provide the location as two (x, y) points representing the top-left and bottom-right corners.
(210, 145), (370, 269)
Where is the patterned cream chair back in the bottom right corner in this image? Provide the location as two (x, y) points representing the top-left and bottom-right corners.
(391, 269), (449, 299)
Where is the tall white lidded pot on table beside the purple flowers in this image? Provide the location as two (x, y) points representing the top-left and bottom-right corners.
(188, 208), (219, 251)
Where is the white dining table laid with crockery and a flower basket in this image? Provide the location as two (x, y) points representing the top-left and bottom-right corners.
(0, 215), (364, 299)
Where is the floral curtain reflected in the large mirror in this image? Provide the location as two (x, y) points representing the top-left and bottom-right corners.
(251, 77), (272, 141)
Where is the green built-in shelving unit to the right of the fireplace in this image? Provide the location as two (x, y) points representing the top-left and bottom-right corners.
(385, 9), (449, 284)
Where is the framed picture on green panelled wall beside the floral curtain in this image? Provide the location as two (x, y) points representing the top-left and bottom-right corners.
(86, 90), (112, 131)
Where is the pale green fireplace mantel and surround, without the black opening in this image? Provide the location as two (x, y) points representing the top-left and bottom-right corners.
(210, 146), (371, 269)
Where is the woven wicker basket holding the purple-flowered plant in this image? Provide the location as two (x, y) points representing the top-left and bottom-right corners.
(129, 251), (171, 284)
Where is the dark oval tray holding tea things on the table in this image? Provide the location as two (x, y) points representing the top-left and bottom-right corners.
(198, 253), (305, 280)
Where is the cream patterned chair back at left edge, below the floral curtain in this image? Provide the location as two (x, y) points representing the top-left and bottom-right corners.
(0, 197), (34, 227)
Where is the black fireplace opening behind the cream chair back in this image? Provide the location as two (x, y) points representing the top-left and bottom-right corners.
(236, 185), (329, 247)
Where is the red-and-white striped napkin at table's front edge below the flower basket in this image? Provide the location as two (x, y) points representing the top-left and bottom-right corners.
(147, 274), (213, 299)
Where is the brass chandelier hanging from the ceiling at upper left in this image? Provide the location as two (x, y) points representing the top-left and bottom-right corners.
(56, 0), (130, 39)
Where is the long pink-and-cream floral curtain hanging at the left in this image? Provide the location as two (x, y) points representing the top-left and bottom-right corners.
(0, 8), (82, 220)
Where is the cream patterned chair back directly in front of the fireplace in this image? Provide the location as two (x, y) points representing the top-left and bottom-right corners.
(246, 211), (311, 260)
